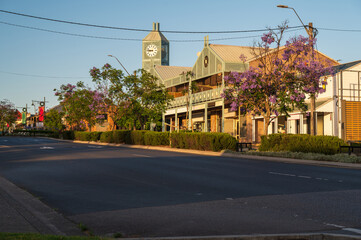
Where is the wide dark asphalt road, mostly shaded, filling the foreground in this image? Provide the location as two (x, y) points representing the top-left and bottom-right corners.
(0, 137), (361, 237)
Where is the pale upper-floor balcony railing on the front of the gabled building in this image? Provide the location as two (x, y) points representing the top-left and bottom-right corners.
(168, 88), (222, 108)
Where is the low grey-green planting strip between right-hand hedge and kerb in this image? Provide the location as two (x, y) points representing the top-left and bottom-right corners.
(225, 150), (361, 163)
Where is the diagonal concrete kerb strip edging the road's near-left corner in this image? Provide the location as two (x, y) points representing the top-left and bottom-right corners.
(0, 176), (84, 236)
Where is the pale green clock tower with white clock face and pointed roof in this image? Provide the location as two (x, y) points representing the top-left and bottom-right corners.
(142, 23), (169, 75)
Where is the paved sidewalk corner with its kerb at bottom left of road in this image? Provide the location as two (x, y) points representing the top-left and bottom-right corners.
(0, 176), (84, 236)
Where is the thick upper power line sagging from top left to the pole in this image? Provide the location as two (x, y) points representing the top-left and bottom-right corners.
(0, 9), (303, 34)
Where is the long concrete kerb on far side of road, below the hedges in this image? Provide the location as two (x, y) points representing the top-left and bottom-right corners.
(69, 140), (361, 169)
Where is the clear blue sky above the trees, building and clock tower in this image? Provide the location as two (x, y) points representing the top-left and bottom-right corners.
(0, 0), (361, 112)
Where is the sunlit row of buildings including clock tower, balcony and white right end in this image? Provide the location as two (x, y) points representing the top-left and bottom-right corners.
(142, 23), (361, 142)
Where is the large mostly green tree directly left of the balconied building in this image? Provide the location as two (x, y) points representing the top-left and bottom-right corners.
(90, 64), (171, 129)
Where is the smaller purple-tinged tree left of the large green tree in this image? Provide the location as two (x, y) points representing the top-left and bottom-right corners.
(54, 82), (107, 130)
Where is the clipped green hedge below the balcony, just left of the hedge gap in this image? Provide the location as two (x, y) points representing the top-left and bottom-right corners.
(170, 132), (237, 152)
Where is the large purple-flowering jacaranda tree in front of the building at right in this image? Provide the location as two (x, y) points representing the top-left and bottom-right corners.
(223, 25), (331, 137)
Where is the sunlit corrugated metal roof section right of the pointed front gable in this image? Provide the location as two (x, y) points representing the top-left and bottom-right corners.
(209, 44), (254, 63)
